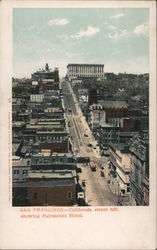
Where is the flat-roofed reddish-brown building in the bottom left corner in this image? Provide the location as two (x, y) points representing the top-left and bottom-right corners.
(13, 170), (77, 206)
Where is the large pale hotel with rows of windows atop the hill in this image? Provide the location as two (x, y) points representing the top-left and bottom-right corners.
(67, 64), (104, 78)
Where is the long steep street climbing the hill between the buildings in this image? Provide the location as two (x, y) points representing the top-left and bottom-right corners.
(62, 79), (117, 206)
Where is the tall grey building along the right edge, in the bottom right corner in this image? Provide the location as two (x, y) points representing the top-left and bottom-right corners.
(130, 132), (149, 205)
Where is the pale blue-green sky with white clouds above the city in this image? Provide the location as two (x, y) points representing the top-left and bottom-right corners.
(13, 8), (149, 77)
